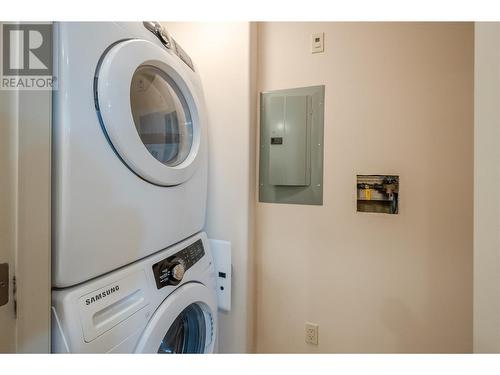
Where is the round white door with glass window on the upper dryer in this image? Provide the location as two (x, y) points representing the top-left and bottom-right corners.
(94, 39), (204, 186)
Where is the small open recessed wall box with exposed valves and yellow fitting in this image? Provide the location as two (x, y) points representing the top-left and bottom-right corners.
(356, 175), (399, 214)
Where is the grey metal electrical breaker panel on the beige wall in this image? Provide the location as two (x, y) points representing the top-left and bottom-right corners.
(259, 86), (325, 205)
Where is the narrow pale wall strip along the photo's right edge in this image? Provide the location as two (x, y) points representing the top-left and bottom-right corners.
(474, 22), (500, 353)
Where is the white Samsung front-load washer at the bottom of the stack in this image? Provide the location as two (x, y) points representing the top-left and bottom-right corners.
(52, 233), (217, 353)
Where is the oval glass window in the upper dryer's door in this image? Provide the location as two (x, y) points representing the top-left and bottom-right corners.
(130, 65), (193, 167)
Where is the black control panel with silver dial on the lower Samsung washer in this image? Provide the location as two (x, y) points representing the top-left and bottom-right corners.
(152, 240), (205, 289)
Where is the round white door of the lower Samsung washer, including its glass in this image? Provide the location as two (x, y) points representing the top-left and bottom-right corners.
(135, 282), (217, 354)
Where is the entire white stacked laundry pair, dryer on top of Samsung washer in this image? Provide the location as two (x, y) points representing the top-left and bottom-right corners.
(52, 22), (217, 353)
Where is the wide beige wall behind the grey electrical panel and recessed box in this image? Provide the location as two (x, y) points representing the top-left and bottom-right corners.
(256, 23), (474, 352)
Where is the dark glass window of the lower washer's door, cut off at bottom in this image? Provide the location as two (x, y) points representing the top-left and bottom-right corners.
(158, 303), (211, 354)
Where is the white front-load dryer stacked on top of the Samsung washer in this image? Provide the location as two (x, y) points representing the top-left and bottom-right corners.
(53, 22), (207, 288)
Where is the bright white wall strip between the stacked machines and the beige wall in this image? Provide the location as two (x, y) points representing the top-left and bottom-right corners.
(165, 22), (255, 353)
